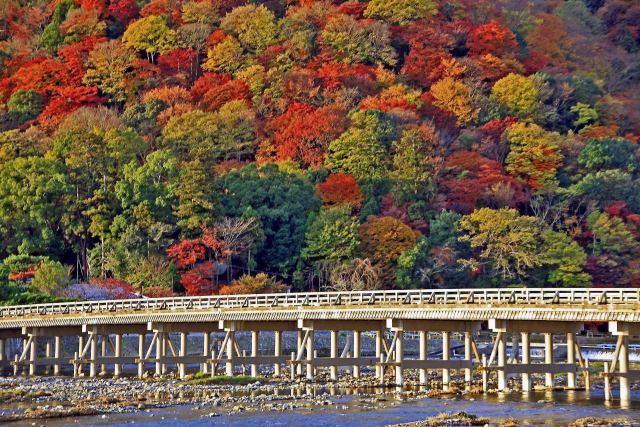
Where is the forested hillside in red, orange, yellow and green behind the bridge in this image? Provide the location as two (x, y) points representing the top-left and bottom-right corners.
(0, 0), (640, 303)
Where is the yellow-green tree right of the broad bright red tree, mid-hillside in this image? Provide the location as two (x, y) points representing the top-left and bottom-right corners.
(325, 110), (396, 180)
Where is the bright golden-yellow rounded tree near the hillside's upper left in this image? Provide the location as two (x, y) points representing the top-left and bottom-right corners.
(122, 15), (177, 63)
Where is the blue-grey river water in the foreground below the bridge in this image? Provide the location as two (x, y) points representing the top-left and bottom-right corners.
(11, 388), (640, 427)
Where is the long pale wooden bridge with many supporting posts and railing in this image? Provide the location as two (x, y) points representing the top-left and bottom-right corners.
(0, 288), (640, 401)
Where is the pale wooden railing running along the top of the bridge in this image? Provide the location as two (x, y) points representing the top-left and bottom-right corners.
(0, 288), (640, 317)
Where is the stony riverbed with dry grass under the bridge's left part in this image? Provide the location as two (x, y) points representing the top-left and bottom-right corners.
(0, 371), (636, 425)
